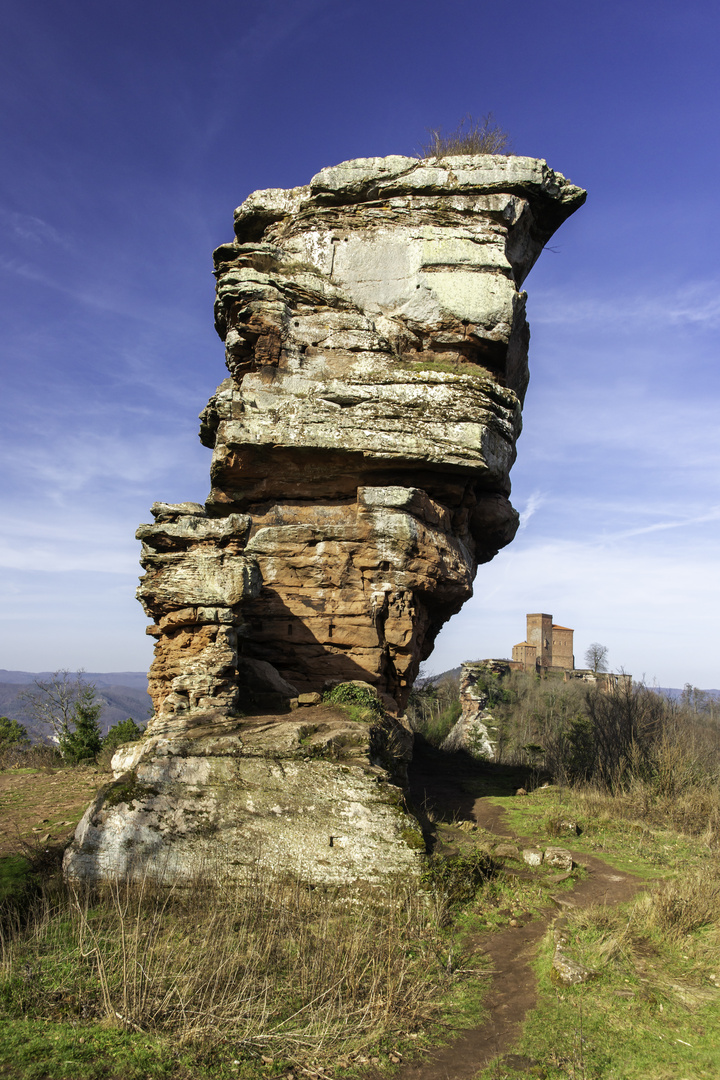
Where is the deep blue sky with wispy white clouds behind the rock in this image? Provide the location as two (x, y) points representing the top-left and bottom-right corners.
(0, 0), (720, 687)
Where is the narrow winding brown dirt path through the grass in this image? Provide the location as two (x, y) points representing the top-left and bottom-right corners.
(397, 747), (644, 1080)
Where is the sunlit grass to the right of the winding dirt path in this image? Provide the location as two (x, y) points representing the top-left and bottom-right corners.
(478, 787), (720, 1080)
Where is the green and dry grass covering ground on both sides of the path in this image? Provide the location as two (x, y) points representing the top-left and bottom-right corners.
(0, 764), (720, 1080)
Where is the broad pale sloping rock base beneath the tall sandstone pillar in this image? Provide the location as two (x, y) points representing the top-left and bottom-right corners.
(64, 705), (425, 886)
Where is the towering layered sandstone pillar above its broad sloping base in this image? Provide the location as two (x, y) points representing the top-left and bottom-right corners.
(63, 156), (585, 878)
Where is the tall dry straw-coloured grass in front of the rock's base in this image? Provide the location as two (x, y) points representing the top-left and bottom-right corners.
(2, 874), (451, 1059)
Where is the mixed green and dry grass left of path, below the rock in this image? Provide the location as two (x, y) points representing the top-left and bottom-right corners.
(0, 864), (500, 1080)
